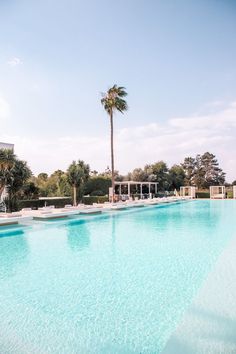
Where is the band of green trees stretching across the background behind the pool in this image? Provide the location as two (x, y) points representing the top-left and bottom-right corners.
(0, 149), (236, 209)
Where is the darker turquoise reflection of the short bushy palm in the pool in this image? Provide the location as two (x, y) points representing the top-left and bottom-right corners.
(67, 221), (90, 252)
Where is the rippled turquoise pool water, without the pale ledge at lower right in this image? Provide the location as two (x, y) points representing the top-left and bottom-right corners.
(0, 201), (236, 354)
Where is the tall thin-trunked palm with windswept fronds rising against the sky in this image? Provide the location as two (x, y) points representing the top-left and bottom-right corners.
(101, 85), (128, 202)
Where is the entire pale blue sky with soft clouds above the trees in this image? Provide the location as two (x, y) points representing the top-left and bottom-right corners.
(0, 0), (236, 181)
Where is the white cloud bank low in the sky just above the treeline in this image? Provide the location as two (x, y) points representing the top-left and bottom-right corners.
(2, 102), (236, 181)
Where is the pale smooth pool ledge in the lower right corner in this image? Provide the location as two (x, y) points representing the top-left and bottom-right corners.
(162, 234), (236, 354)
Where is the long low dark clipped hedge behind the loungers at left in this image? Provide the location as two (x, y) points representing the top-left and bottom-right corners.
(17, 197), (72, 210)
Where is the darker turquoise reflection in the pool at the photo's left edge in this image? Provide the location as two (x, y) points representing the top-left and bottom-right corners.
(0, 229), (29, 278)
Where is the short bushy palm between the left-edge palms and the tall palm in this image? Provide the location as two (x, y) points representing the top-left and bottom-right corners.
(67, 160), (90, 205)
